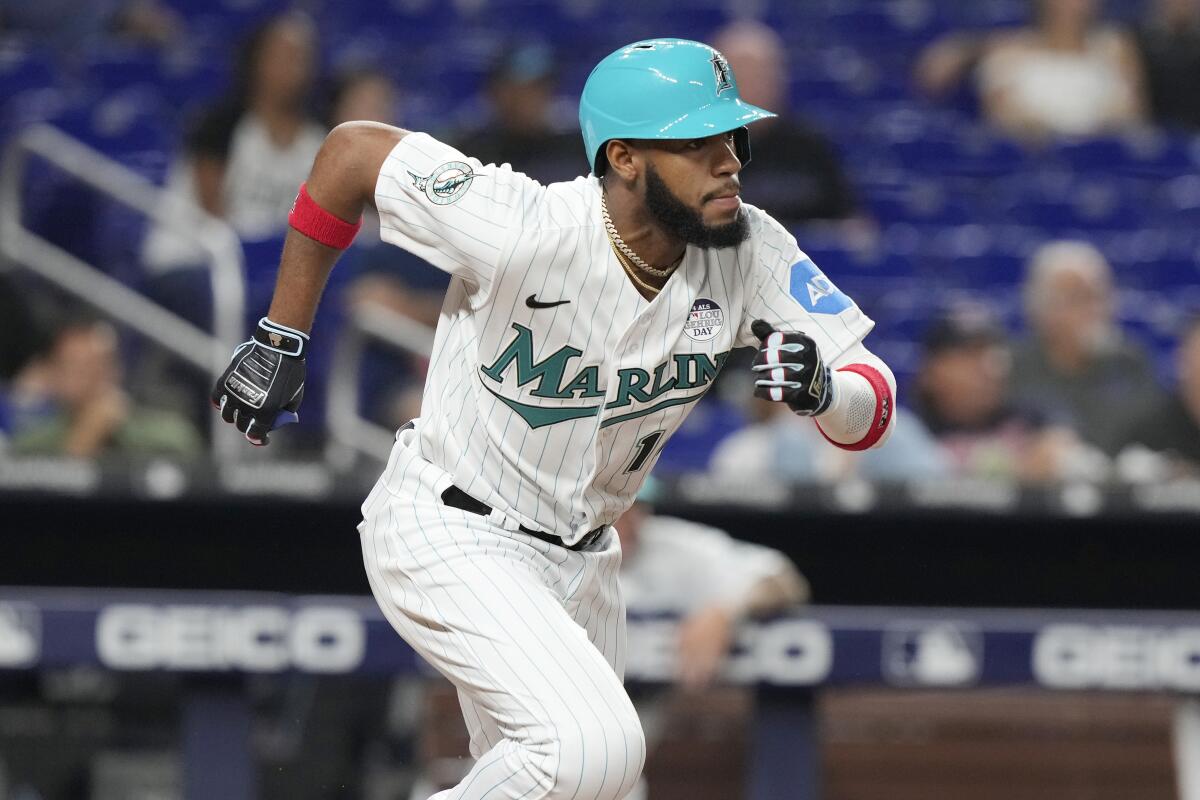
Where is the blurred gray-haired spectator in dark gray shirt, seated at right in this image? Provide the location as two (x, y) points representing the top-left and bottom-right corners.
(1013, 241), (1160, 453)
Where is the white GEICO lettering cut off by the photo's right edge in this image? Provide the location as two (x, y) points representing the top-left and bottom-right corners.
(1033, 625), (1200, 691)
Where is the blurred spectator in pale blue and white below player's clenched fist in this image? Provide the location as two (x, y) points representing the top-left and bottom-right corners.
(708, 398), (950, 482)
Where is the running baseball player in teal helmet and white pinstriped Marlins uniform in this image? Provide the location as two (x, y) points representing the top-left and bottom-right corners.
(212, 40), (895, 800)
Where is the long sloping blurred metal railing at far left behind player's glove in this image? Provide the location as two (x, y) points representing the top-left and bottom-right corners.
(0, 125), (247, 458)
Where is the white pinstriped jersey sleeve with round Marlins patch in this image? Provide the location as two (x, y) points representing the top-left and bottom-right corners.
(376, 133), (544, 293)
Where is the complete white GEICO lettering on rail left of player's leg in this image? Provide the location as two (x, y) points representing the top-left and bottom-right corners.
(96, 603), (366, 673)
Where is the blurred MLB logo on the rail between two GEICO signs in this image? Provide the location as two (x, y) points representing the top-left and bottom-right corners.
(882, 621), (983, 686)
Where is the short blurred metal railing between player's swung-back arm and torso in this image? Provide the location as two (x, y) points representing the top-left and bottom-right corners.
(325, 306), (433, 468)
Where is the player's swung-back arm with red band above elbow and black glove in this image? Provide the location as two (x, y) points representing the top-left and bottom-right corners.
(210, 122), (407, 445)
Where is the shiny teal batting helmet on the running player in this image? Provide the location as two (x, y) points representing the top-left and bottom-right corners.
(580, 38), (775, 175)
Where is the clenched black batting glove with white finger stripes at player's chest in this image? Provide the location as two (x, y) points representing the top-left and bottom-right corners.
(750, 319), (833, 416)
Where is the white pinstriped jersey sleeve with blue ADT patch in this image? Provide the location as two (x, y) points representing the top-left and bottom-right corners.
(737, 211), (875, 363)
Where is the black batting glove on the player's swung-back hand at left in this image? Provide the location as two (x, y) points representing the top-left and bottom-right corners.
(210, 317), (308, 446)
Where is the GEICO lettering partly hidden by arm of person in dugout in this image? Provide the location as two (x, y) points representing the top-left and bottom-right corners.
(626, 619), (833, 686)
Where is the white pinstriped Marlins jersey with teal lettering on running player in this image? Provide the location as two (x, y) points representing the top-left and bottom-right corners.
(376, 133), (874, 543)
